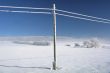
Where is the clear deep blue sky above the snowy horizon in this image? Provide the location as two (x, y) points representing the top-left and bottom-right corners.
(0, 0), (110, 37)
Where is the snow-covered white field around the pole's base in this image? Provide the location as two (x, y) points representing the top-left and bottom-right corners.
(0, 39), (110, 73)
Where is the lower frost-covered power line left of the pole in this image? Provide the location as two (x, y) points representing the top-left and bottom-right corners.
(0, 10), (51, 14)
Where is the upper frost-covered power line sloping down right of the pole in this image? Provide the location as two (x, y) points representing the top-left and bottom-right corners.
(56, 9), (110, 21)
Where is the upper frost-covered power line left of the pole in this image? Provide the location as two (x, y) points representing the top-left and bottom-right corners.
(0, 6), (52, 10)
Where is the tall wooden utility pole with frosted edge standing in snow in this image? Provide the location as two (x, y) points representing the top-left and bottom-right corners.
(53, 4), (56, 70)
